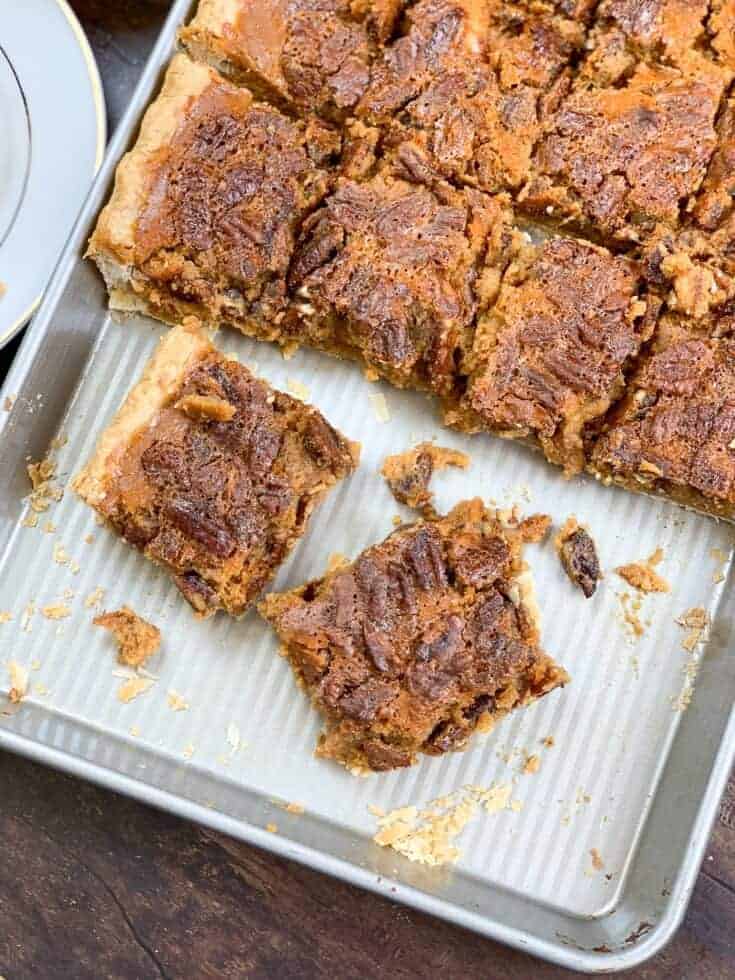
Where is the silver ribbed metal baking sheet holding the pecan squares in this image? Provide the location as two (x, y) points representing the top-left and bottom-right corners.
(0, 0), (735, 972)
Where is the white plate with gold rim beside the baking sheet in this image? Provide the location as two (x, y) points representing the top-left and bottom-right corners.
(0, 0), (106, 347)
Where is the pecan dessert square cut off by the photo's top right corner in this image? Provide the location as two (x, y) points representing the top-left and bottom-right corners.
(580, 0), (735, 85)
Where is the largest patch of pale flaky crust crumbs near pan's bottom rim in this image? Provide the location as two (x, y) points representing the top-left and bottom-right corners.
(369, 786), (518, 867)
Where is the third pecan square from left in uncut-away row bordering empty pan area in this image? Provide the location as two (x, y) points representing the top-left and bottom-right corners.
(447, 238), (653, 473)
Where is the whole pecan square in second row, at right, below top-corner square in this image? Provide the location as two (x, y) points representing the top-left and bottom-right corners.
(519, 64), (724, 242)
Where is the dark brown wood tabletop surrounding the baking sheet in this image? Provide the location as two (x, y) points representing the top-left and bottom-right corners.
(0, 0), (735, 980)
